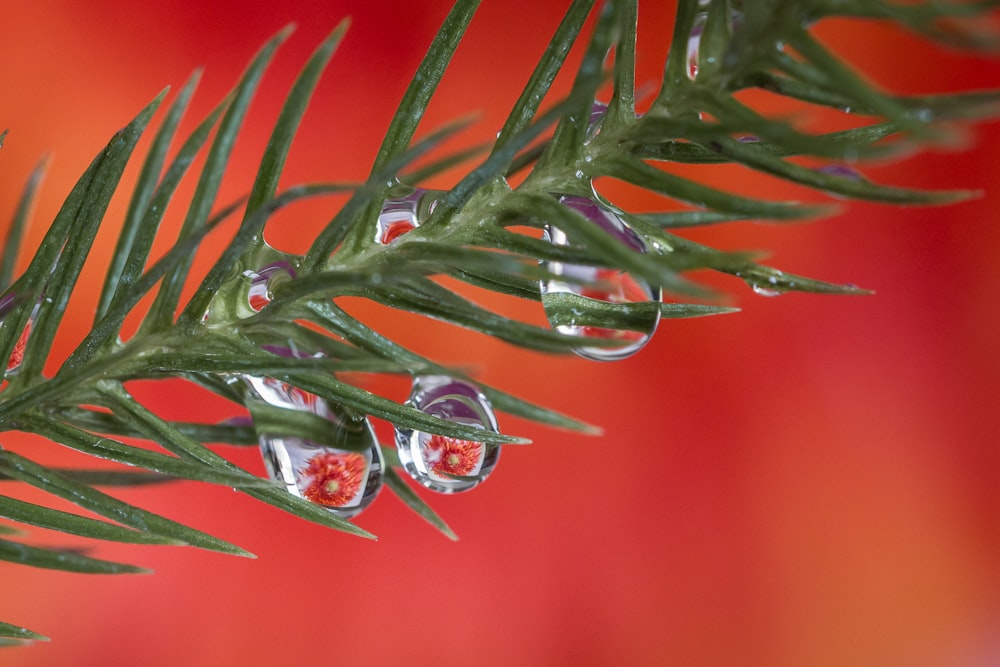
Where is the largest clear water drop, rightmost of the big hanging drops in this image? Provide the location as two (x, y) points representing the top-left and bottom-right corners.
(541, 196), (661, 361)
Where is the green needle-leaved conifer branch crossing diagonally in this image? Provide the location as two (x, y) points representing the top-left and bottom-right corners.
(0, 0), (1000, 643)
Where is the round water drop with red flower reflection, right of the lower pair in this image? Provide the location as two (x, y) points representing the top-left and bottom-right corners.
(396, 375), (500, 493)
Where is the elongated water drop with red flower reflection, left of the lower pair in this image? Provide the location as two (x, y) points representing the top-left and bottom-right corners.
(244, 377), (385, 519)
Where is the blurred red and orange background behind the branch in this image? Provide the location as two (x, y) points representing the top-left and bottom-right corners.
(0, 0), (1000, 667)
